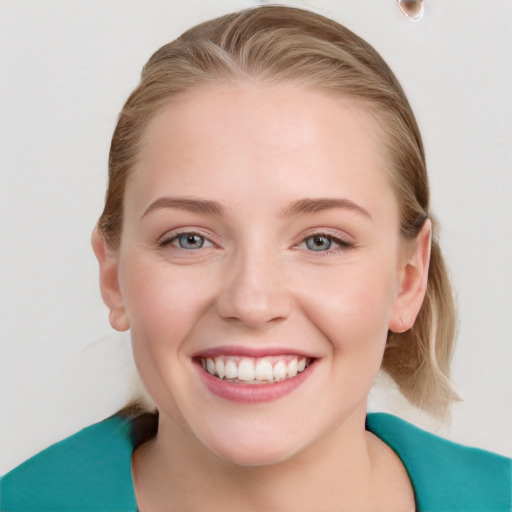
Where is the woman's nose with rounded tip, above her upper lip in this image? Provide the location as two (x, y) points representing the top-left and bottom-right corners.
(217, 248), (292, 328)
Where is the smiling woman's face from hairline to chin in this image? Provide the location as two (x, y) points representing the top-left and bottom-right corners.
(99, 84), (424, 465)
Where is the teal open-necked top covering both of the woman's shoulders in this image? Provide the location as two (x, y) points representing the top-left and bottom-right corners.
(0, 413), (512, 512)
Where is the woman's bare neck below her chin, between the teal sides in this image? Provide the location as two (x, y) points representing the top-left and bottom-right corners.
(133, 409), (382, 512)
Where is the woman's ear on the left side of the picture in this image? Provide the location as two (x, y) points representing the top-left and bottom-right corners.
(91, 227), (130, 331)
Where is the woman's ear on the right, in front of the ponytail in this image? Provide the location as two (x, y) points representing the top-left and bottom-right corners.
(389, 219), (432, 333)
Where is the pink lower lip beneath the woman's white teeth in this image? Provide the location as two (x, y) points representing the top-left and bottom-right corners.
(197, 363), (315, 404)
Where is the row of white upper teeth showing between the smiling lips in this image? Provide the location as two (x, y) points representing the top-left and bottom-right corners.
(198, 355), (312, 384)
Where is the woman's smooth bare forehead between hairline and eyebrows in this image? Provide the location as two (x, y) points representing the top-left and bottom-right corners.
(127, 83), (396, 219)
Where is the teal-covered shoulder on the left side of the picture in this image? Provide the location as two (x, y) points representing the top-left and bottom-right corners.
(1, 416), (136, 512)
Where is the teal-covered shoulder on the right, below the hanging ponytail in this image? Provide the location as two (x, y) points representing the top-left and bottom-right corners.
(367, 413), (512, 512)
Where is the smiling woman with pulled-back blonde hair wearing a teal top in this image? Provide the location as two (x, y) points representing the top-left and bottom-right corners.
(2, 7), (511, 511)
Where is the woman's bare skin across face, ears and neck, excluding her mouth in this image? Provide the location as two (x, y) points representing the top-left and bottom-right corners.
(93, 83), (431, 512)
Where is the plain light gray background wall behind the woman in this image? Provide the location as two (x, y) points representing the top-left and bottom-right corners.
(0, 0), (512, 473)
